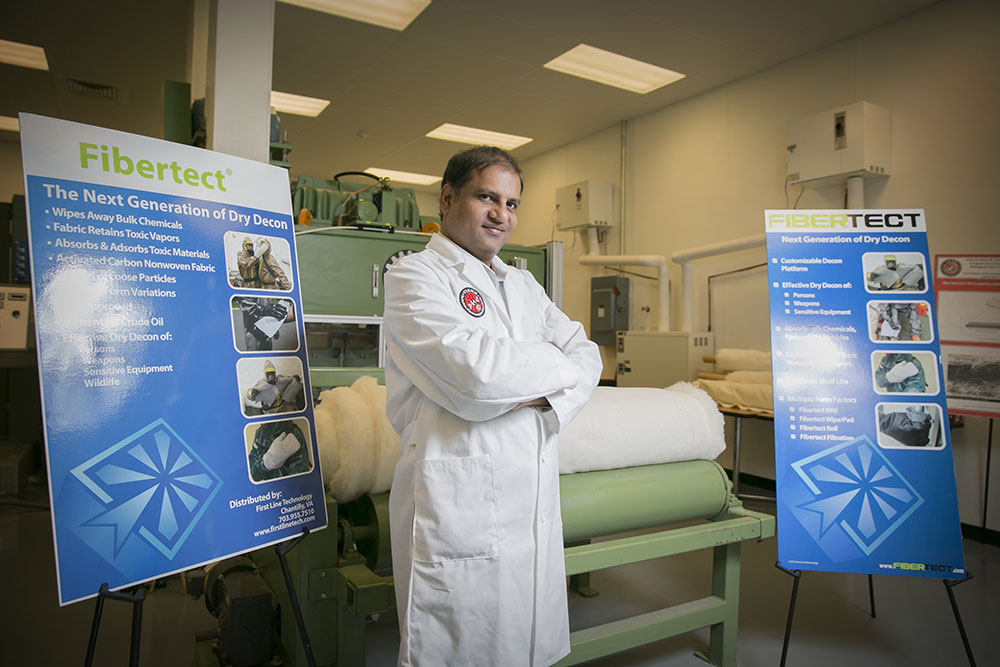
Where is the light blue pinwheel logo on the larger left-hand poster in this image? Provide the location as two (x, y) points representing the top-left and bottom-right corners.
(72, 419), (222, 560)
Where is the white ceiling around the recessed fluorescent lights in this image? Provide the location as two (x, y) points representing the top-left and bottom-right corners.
(0, 0), (933, 193)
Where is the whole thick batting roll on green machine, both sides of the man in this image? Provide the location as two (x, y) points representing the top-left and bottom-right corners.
(315, 377), (726, 503)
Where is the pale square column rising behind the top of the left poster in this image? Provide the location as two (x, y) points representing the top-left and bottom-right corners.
(205, 0), (274, 162)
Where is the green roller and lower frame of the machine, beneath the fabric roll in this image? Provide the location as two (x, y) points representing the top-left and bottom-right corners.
(253, 461), (775, 667)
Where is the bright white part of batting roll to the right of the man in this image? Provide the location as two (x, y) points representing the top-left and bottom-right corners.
(559, 382), (726, 474)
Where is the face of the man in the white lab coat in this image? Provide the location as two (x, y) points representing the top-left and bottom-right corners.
(440, 165), (521, 264)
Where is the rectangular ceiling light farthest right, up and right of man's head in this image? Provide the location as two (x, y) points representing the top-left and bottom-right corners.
(545, 44), (684, 95)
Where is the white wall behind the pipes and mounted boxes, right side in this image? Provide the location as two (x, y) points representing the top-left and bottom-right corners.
(512, 0), (1000, 530)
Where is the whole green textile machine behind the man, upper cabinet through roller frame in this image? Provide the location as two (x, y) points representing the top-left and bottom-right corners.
(240, 184), (774, 667)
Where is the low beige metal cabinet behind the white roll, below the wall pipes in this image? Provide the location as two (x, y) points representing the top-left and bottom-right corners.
(616, 331), (715, 387)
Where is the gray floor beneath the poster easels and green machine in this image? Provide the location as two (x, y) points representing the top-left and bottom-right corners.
(0, 482), (1000, 667)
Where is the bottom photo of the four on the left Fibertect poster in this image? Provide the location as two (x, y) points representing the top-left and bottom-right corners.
(247, 419), (313, 482)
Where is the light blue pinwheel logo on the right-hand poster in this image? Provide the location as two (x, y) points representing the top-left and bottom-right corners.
(792, 436), (924, 555)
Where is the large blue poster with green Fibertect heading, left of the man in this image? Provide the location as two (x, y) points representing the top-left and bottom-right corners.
(21, 115), (326, 604)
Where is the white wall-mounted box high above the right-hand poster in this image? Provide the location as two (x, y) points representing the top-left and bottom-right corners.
(787, 102), (890, 188)
